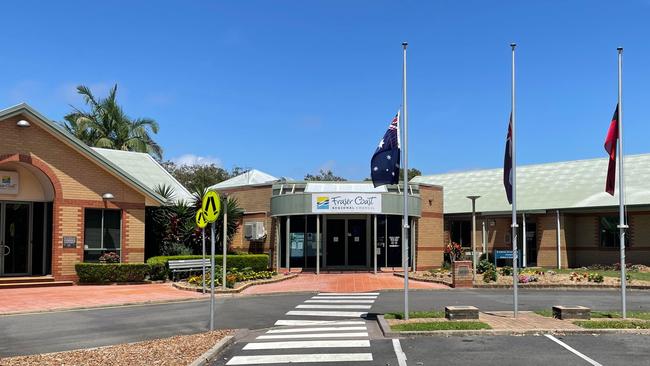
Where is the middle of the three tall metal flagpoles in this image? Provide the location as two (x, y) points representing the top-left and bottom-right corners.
(510, 43), (519, 318)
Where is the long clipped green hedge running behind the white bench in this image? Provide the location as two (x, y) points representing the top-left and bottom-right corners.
(147, 254), (269, 280)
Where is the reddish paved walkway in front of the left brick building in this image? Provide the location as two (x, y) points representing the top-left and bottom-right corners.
(0, 283), (203, 314)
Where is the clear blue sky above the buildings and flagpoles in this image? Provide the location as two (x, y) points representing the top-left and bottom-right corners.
(0, 0), (650, 179)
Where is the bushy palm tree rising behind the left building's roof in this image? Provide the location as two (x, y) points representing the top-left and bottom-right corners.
(63, 84), (162, 160)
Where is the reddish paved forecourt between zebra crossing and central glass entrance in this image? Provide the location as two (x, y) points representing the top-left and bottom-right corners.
(242, 273), (448, 294)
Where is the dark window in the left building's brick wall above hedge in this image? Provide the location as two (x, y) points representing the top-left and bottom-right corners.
(84, 208), (122, 262)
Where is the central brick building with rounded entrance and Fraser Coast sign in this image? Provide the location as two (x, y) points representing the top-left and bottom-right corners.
(212, 170), (443, 270)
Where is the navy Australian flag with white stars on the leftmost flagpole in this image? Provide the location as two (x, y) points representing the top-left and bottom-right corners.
(370, 111), (400, 187)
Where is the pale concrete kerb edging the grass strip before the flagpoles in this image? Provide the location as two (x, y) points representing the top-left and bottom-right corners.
(377, 314), (650, 338)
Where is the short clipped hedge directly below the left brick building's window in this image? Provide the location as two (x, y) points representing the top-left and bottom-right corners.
(74, 263), (150, 283)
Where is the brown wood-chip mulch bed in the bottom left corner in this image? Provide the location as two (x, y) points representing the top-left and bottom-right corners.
(0, 329), (232, 366)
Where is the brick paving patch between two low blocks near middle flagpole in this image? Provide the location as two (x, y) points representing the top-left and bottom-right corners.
(479, 311), (582, 331)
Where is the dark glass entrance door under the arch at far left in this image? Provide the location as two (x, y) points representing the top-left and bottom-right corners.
(0, 202), (31, 275)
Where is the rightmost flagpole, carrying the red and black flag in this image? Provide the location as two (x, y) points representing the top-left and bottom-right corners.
(617, 47), (628, 319)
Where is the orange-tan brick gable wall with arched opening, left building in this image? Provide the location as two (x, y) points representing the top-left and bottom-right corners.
(0, 115), (145, 280)
